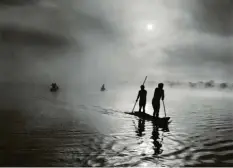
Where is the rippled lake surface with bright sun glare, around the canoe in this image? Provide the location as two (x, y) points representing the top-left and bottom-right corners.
(0, 85), (233, 166)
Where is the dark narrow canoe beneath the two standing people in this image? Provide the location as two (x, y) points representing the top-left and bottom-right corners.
(125, 112), (171, 124)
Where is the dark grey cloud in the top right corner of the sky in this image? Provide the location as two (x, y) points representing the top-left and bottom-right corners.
(189, 0), (233, 36)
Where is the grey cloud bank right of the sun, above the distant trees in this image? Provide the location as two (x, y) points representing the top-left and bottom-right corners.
(163, 44), (233, 79)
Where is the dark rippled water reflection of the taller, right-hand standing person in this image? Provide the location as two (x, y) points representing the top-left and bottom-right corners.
(151, 122), (163, 155)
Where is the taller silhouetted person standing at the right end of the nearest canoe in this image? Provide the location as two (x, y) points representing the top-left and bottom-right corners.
(152, 83), (164, 118)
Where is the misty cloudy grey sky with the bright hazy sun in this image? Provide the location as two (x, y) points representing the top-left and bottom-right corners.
(0, 0), (233, 84)
